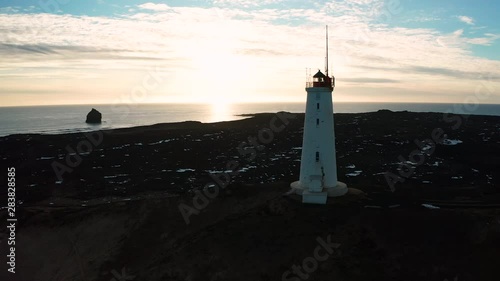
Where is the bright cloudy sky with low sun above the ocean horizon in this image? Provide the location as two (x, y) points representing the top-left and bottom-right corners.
(0, 0), (500, 106)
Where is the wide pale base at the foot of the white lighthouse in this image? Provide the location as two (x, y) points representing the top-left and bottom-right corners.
(290, 181), (347, 204)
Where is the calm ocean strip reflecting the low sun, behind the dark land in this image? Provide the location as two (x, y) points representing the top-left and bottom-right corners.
(0, 102), (500, 136)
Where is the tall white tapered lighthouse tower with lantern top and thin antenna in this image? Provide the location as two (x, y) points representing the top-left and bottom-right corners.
(291, 26), (347, 204)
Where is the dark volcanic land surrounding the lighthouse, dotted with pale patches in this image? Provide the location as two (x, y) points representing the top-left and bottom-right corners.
(0, 110), (500, 281)
